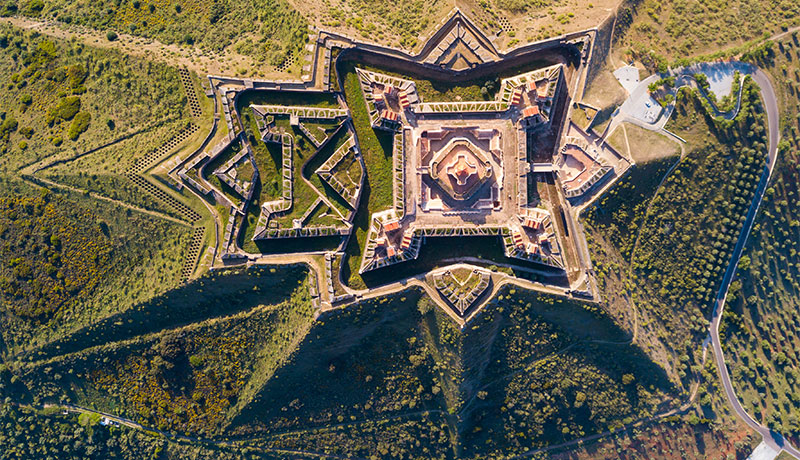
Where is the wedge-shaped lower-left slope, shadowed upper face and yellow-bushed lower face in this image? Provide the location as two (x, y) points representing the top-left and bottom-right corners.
(14, 267), (312, 435)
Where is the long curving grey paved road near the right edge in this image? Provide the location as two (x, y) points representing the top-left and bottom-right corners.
(709, 70), (800, 459)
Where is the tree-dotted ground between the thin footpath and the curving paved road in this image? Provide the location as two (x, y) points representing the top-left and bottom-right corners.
(632, 81), (767, 342)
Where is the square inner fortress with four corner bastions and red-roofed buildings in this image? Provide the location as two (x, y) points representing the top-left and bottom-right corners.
(356, 64), (564, 273)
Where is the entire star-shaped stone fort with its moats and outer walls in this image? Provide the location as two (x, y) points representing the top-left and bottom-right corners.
(169, 10), (632, 324)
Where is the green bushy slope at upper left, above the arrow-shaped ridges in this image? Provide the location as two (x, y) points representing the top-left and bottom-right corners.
(0, 25), (185, 171)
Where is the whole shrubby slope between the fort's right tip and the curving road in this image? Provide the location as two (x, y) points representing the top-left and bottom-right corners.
(586, 75), (767, 398)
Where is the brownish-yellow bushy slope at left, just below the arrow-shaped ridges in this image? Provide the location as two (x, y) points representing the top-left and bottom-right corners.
(0, 183), (190, 354)
